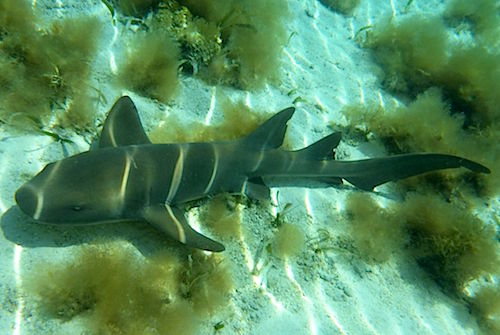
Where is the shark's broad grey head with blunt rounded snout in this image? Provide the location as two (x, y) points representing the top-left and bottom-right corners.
(15, 150), (129, 224)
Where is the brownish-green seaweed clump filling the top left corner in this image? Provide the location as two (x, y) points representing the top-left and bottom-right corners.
(0, 0), (102, 129)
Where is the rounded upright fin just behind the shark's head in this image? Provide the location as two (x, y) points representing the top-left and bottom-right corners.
(99, 96), (151, 148)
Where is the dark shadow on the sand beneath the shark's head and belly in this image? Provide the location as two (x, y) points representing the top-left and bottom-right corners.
(0, 206), (185, 256)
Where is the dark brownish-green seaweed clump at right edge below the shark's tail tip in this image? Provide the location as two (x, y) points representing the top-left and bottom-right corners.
(399, 194), (500, 295)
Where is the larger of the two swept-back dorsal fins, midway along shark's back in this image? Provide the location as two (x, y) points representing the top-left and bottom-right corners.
(241, 107), (295, 150)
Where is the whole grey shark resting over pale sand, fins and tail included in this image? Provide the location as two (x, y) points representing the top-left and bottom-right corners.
(15, 96), (490, 252)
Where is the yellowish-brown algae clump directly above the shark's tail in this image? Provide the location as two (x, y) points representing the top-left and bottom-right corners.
(342, 88), (464, 154)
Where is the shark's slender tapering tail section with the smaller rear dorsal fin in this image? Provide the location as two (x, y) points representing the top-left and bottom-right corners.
(264, 133), (490, 190)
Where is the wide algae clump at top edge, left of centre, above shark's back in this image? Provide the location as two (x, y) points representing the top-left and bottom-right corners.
(106, 0), (289, 98)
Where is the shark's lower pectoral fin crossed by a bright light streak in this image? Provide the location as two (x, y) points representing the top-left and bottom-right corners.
(142, 204), (225, 252)
